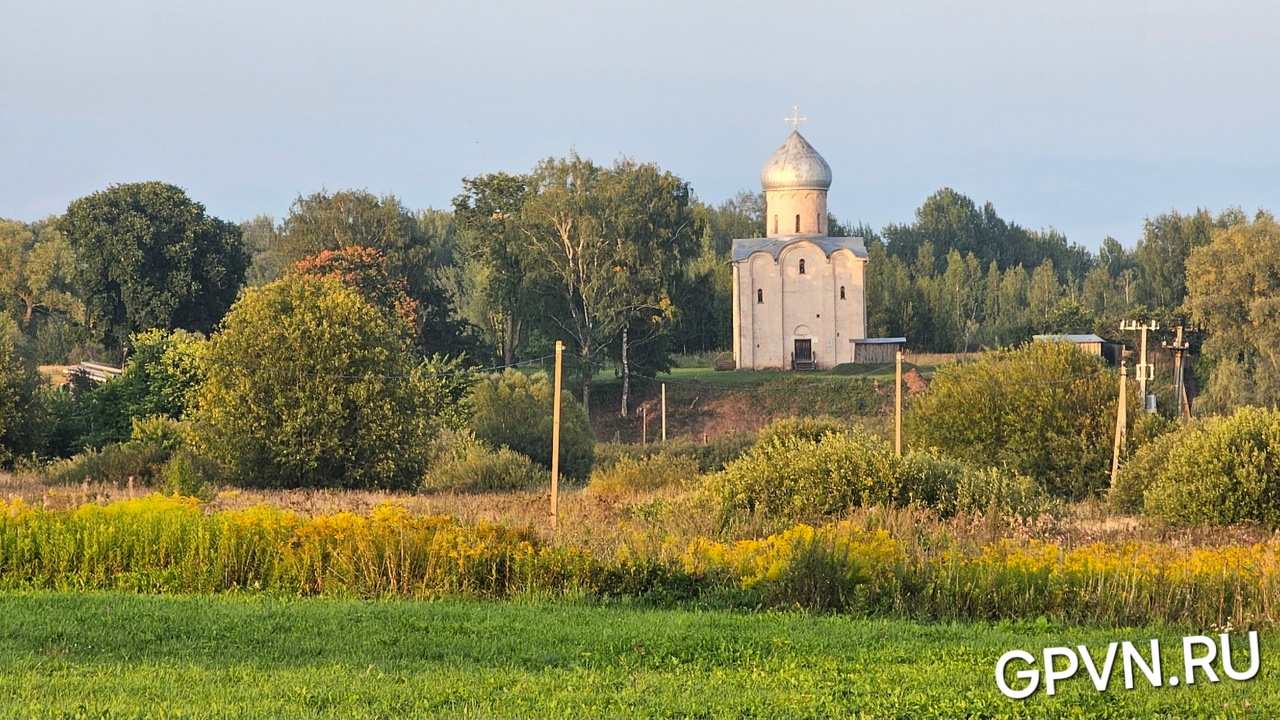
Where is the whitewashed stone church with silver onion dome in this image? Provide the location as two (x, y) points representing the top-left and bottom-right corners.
(732, 129), (867, 370)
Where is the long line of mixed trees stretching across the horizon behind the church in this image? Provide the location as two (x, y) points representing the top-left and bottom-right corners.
(0, 154), (1280, 438)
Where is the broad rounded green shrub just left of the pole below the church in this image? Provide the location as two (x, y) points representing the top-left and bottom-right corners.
(713, 427), (897, 519)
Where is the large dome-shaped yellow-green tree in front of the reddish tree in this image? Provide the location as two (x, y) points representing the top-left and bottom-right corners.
(193, 275), (467, 489)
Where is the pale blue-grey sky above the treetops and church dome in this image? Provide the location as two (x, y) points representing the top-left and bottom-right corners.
(0, 0), (1280, 249)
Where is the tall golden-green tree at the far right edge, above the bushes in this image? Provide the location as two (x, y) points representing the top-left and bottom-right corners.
(1187, 210), (1280, 411)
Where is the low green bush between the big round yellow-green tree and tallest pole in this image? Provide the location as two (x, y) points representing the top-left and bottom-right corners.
(422, 432), (549, 492)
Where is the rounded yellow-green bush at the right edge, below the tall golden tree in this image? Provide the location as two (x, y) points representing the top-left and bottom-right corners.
(1146, 407), (1280, 528)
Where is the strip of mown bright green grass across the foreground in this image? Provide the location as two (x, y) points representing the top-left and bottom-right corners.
(0, 593), (1280, 717)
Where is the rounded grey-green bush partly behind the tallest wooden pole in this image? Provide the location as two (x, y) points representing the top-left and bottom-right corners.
(470, 370), (595, 480)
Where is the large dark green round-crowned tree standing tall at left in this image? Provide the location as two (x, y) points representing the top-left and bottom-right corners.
(59, 182), (248, 345)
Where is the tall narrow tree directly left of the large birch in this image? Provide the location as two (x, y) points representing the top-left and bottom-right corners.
(453, 173), (532, 366)
